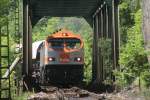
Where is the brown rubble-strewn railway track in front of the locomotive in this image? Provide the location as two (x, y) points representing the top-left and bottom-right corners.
(27, 86), (106, 100)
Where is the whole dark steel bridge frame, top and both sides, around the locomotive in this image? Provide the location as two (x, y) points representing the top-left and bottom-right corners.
(1, 0), (119, 99)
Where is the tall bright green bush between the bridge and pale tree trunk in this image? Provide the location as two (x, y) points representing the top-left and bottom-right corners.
(114, 9), (149, 86)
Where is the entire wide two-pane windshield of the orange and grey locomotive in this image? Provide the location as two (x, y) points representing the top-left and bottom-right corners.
(48, 38), (81, 49)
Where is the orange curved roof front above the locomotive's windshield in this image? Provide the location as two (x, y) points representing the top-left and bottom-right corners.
(47, 29), (81, 39)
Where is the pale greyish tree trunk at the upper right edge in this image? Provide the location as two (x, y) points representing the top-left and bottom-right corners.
(142, 0), (150, 62)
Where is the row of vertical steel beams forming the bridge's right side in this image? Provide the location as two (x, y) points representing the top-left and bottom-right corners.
(92, 0), (120, 83)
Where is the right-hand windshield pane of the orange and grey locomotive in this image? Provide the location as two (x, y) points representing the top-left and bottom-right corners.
(65, 39), (81, 49)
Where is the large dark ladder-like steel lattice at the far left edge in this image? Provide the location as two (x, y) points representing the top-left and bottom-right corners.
(0, 18), (11, 100)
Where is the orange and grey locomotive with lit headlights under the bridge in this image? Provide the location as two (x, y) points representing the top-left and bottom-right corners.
(32, 29), (84, 85)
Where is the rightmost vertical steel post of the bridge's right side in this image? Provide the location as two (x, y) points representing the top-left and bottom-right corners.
(108, 0), (120, 81)
